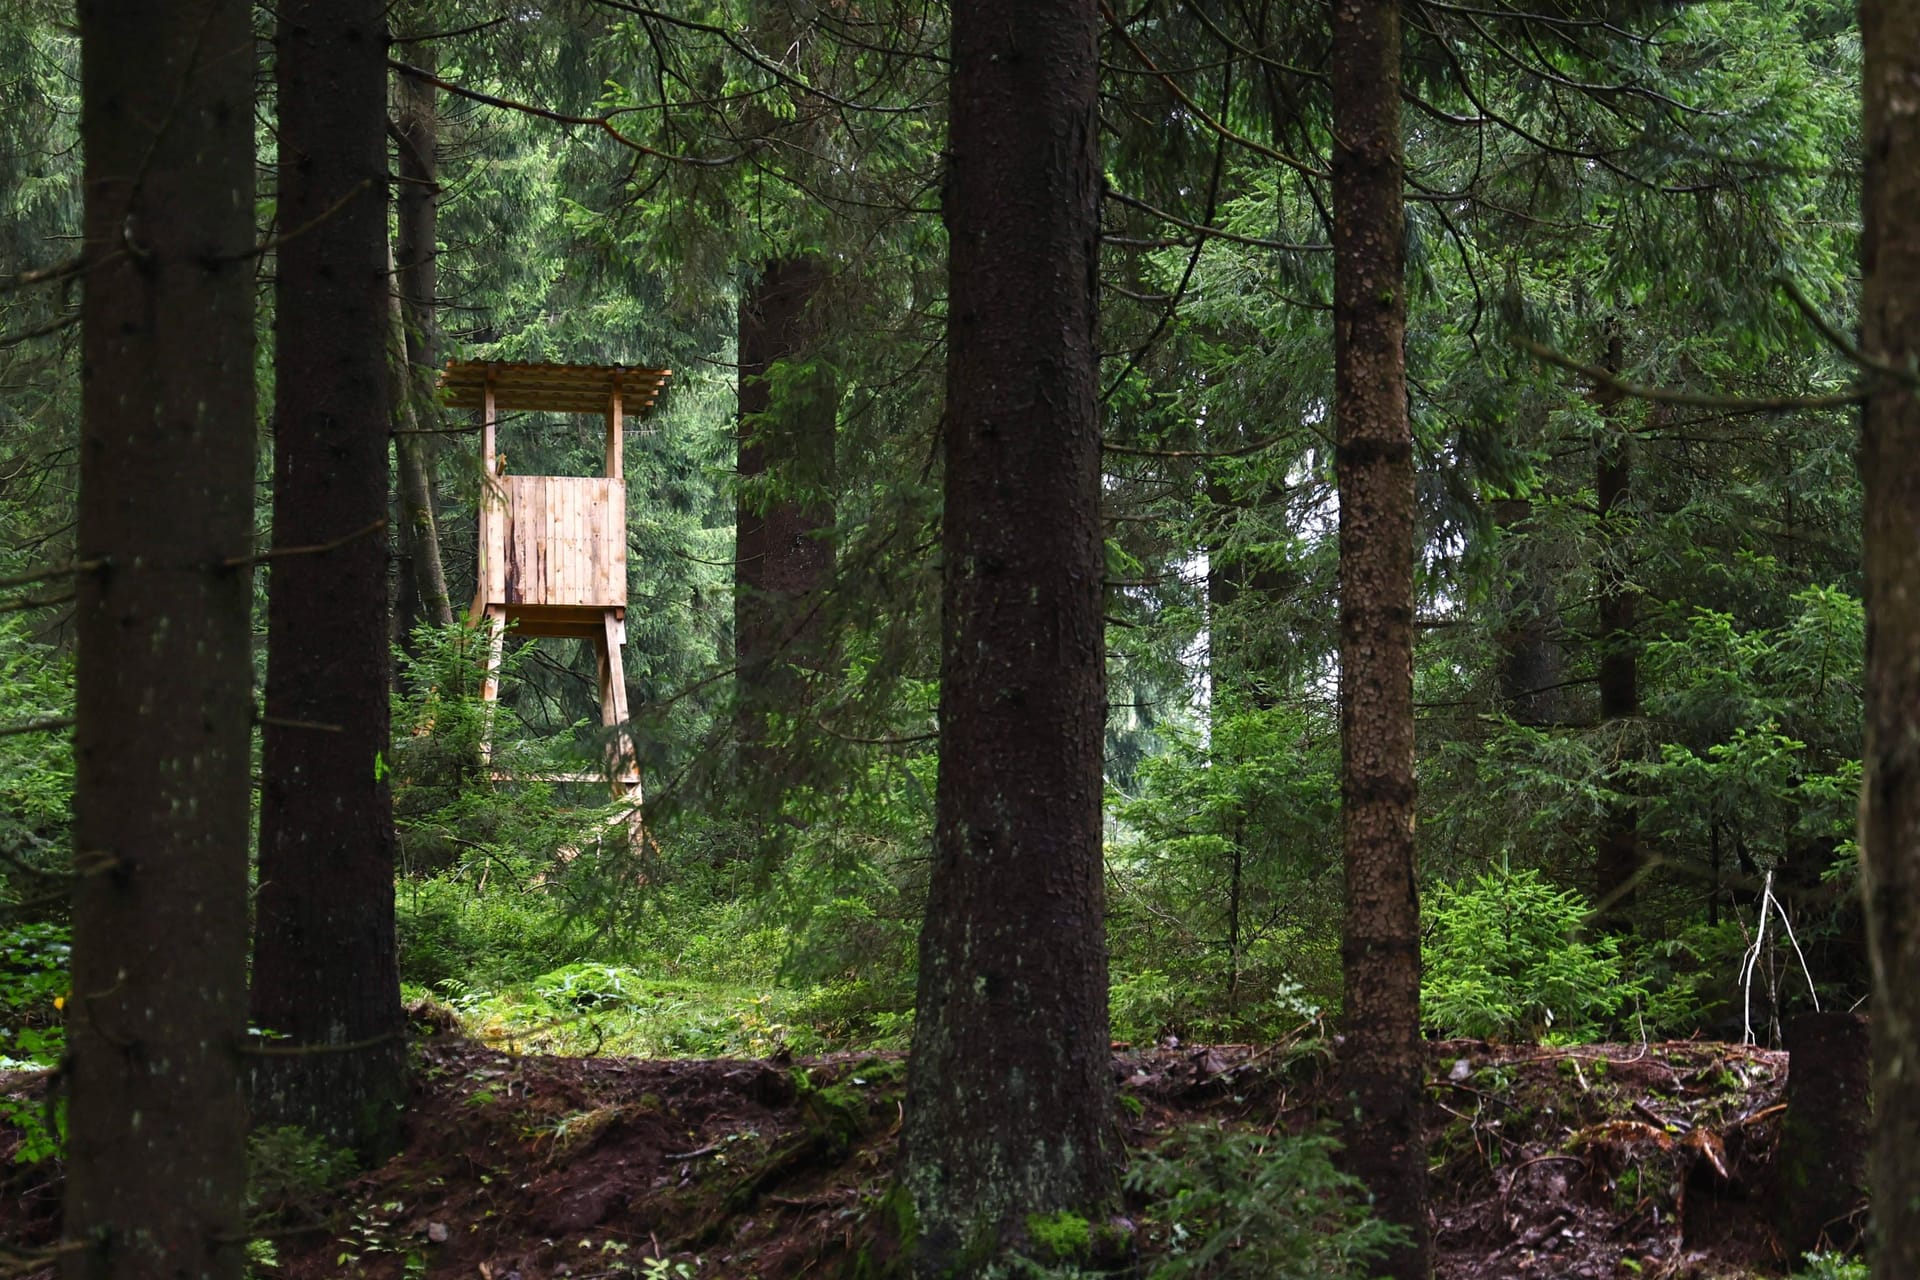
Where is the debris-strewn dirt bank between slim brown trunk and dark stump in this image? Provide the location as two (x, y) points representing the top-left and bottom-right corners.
(1428, 1042), (1788, 1280)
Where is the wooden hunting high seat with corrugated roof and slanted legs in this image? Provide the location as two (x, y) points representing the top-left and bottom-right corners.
(440, 361), (672, 802)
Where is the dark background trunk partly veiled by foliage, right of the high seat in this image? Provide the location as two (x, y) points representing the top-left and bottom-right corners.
(733, 257), (839, 781)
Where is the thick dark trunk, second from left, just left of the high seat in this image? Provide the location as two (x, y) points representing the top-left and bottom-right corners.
(250, 0), (405, 1157)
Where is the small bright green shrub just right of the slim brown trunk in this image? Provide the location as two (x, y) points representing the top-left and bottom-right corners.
(1421, 867), (1644, 1044)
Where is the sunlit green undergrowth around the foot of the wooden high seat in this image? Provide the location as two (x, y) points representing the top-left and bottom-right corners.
(394, 628), (933, 1055)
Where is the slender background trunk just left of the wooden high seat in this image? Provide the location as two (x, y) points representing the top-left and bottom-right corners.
(394, 22), (453, 631)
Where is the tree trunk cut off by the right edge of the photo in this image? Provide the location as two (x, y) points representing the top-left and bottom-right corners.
(1860, 0), (1920, 1280)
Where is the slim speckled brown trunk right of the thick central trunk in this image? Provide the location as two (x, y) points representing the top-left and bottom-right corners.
(1332, 0), (1430, 1280)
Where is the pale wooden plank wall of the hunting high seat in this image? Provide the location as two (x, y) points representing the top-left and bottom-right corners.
(486, 476), (626, 608)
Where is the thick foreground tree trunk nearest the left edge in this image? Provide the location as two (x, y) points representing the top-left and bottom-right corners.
(63, 0), (257, 1280)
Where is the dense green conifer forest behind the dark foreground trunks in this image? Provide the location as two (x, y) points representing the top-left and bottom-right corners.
(0, 0), (1912, 1274)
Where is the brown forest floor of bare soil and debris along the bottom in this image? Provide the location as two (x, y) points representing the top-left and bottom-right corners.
(0, 1023), (1827, 1280)
